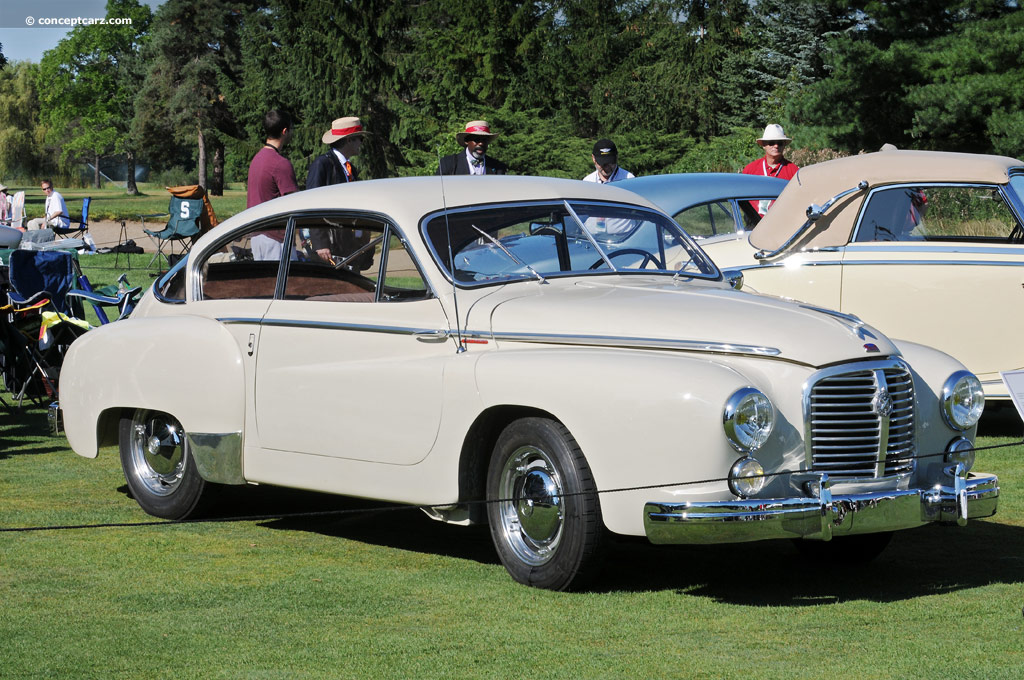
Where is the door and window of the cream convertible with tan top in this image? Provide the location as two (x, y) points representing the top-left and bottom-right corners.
(841, 184), (1024, 392)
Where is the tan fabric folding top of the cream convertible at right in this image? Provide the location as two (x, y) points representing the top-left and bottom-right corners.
(751, 151), (1024, 251)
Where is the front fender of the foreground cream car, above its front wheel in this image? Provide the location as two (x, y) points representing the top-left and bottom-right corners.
(476, 348), (770, 536)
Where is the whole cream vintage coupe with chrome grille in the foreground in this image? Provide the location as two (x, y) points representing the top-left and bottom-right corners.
(60, 177), (998, 589)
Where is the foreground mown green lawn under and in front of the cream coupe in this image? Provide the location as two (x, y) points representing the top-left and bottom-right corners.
(0, 391), (1024, 680)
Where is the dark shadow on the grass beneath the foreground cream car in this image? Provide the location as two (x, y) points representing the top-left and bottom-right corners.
(151, 477), (1024, 607)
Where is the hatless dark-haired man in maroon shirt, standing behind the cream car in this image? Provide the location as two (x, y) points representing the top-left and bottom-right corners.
(246, 110), (299, 260)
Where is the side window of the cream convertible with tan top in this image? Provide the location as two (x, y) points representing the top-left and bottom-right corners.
(857, 186), (1017, 243)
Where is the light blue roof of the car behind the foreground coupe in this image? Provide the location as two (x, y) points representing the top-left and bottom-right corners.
(615, 172), (787, 215)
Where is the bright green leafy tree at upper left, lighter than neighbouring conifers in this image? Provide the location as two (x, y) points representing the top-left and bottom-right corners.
(39, 0), (152, 195)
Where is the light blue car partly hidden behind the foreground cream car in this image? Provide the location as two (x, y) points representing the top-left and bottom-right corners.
(615, 172), (788, 239)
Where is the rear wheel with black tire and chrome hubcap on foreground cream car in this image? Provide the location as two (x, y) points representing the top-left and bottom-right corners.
(119, 409), (206, 519)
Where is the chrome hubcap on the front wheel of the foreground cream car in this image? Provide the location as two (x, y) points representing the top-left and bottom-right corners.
(499, 447), (564, 566)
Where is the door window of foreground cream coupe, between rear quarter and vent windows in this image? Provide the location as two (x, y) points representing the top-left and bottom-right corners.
(285, 216), (386, 302)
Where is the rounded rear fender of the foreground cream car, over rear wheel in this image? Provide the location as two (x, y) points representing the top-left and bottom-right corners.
(59, 315), (245, 458)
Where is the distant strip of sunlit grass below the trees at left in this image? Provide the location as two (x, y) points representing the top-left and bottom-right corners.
(7, 182), (246, 221)
